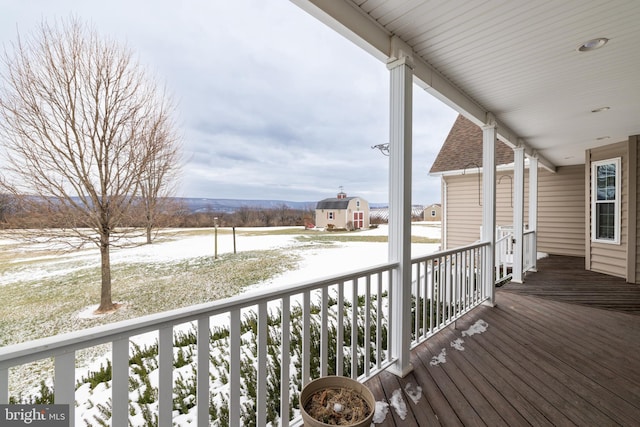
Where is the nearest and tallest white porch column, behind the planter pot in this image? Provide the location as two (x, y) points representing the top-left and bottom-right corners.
(387, 56), (413, 377)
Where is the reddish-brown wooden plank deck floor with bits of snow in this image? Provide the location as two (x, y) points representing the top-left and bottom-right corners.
(367, 259), (640, 426)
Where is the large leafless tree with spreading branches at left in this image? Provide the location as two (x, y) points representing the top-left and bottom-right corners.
(0, 19), (180, 313)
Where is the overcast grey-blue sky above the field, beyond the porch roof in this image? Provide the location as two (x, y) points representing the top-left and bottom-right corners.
(0, 0), (456, 204)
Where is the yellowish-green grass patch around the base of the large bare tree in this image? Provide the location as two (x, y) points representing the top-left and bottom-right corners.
(0, 250), (299, 346)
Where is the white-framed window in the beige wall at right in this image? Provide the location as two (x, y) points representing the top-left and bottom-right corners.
(591, 157), (621, 243)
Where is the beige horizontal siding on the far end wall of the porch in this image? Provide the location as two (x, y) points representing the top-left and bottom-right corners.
(537, 165), (585, 257)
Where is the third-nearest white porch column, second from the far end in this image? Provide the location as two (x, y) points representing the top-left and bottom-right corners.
(511, 146), (524, 283)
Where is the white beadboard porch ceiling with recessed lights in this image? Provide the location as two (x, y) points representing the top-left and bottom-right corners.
(292, 0), (640, 170)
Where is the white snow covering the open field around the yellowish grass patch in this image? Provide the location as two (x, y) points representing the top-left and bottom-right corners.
(0, 222), (440, 286)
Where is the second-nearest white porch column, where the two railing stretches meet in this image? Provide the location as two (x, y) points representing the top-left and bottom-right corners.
(481, 114), (498, 306)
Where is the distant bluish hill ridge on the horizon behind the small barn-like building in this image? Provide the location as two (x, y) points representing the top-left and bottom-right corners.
(176, 197), (387, 213)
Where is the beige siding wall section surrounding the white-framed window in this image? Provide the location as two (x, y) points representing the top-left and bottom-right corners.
(584, 142), (635, 278)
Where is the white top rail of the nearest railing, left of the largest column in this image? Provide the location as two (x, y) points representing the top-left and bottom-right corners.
(0, 262), (398, 369)
